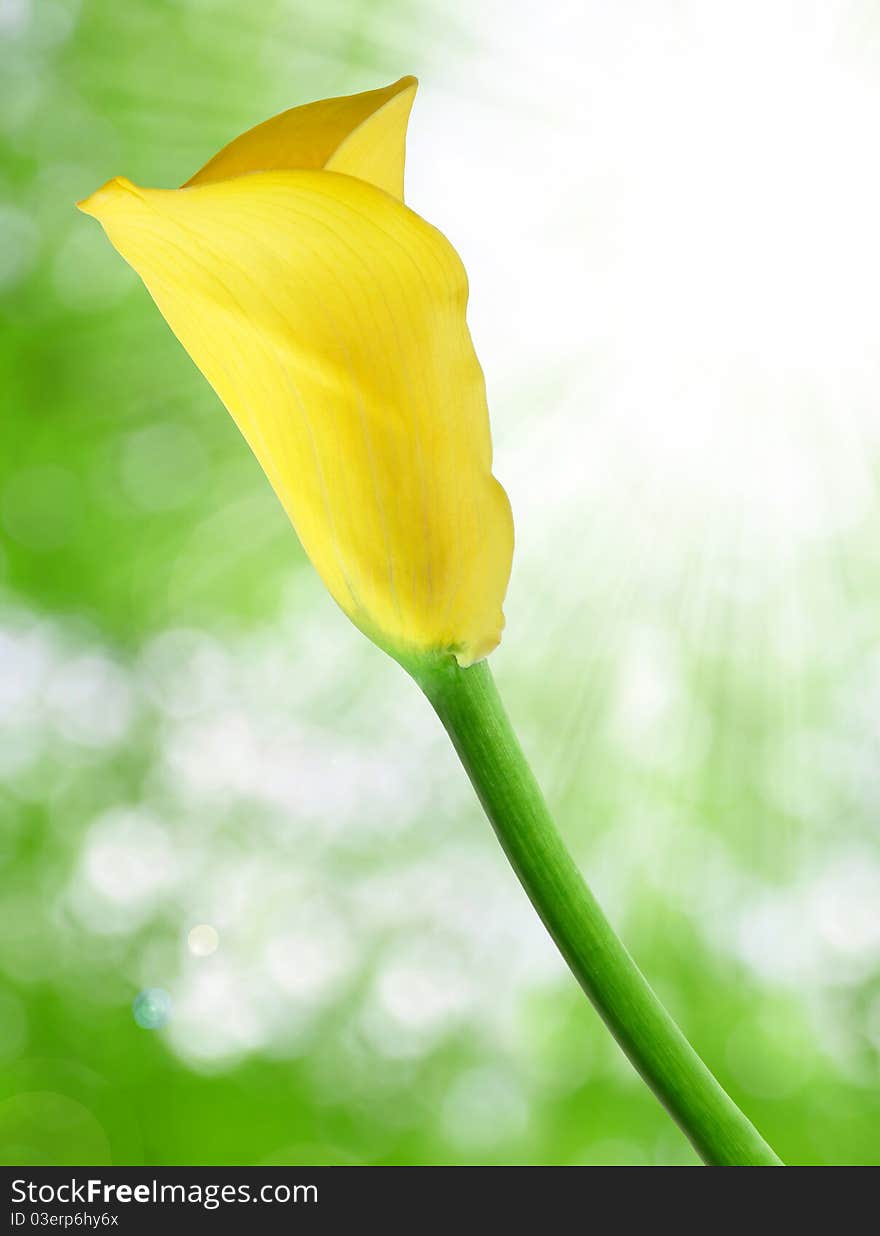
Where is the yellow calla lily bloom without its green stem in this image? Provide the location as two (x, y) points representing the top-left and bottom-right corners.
(79, 78), (513, 665)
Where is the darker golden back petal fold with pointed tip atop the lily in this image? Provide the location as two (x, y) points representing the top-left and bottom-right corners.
(184, 77), (418, 200)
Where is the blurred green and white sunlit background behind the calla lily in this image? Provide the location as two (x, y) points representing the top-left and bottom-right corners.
(0, 0), (880, 1164)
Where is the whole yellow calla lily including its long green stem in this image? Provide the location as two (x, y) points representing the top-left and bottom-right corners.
(79, 78), (781, 1166)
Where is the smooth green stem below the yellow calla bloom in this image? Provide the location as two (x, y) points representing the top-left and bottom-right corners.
(408, 658), (781, 1167)
